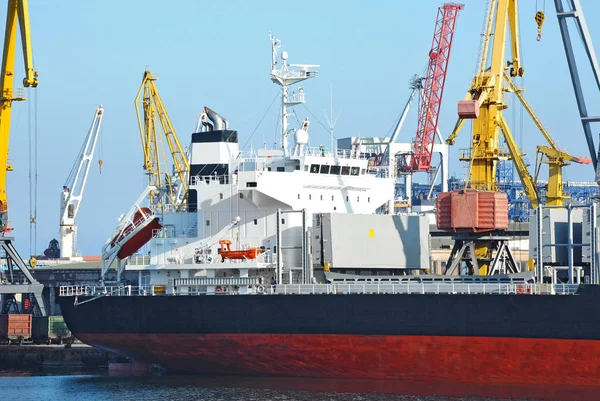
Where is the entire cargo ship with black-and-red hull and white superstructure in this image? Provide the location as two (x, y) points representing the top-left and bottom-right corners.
(59, 37), (600, 386)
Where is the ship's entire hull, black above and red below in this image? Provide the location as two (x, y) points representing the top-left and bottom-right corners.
(60, 286), (600, 386)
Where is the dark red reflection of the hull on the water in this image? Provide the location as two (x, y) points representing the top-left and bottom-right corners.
(69, 375), (600, 401)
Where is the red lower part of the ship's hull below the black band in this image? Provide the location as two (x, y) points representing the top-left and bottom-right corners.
(78, 333), (600, 390)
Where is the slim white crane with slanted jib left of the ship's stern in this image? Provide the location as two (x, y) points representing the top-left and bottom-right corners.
(60, 105), (104, 259)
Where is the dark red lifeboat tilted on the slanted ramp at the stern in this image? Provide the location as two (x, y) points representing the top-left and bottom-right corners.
(110, 207), (162, 259)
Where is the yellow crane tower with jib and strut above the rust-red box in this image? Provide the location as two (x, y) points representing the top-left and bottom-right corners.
(446, 0), (539, 207)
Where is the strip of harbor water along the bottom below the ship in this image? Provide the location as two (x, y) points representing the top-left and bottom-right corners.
(0, 370), (597, 401)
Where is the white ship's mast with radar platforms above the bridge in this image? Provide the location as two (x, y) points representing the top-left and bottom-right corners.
(269, 34), (319, 156)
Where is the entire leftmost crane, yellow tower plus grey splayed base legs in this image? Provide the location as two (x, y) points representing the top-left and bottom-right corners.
(0, 0), (46, 316)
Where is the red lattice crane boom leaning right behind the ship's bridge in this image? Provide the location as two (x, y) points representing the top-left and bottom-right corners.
(410, 3), (465, 171)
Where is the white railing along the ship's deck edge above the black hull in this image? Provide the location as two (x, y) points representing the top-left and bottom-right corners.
(59, 277), (578, 297)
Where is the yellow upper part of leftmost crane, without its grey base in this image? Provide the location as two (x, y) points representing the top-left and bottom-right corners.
(0, 0), (38, 234)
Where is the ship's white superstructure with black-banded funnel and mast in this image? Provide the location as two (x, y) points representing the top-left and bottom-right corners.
(106, 36), (394, 293)
